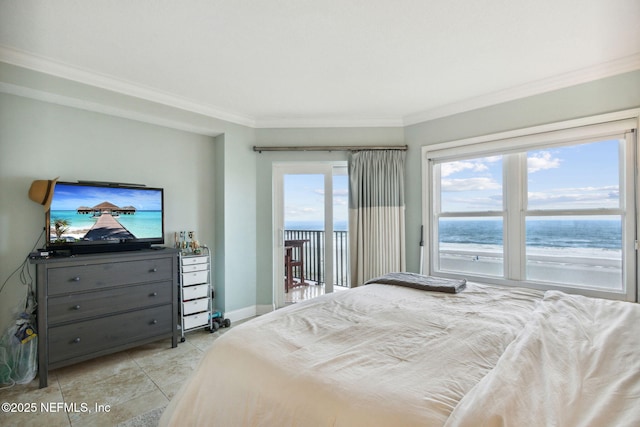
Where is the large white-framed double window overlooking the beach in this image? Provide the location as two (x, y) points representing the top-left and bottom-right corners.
(425, 113), (637, 300)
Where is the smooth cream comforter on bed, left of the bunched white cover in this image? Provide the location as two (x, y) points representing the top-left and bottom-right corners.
(160, 284), (542, 427)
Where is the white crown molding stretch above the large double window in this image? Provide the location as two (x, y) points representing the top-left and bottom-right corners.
(403, 52), (640, 126)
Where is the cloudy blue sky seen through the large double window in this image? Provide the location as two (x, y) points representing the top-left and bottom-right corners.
(441, 140), (620, 212)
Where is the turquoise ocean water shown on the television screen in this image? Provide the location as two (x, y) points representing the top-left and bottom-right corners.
(50, 210), (162, 239)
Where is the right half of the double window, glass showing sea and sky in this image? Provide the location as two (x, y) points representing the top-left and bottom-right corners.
(525, 139), (620, 292)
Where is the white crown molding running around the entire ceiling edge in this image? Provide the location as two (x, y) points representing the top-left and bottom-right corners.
(0, 45), (640, 130)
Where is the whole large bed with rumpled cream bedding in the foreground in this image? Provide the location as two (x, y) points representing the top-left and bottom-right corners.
(160, 276), (640, 427)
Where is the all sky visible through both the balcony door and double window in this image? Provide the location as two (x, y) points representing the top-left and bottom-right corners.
(284, 140), (620, 226)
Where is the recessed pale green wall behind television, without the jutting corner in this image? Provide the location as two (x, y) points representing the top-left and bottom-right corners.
(0, 94), (215, 331)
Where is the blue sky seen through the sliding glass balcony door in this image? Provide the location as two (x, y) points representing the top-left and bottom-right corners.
(284, 174), (349, 223)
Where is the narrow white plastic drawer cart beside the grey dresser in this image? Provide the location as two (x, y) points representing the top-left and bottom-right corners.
(179, 248), (218, 342)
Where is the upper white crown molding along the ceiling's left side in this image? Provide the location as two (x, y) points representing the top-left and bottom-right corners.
(0, 45), (255, 127)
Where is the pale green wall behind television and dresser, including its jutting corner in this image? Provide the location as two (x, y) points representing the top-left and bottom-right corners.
(0, 63), (256, 332)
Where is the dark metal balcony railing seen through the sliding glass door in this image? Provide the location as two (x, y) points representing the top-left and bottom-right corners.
(284, 230), (349, 287)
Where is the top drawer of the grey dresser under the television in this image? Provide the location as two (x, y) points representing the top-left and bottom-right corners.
(47, 258), (173, 295)
